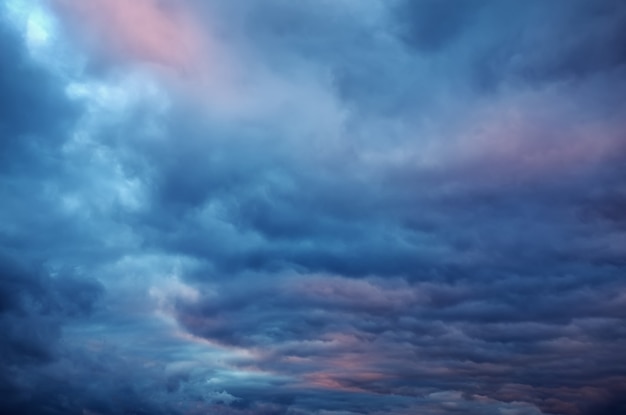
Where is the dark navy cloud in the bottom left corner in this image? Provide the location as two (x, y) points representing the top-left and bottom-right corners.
(0, 253), (102, 414)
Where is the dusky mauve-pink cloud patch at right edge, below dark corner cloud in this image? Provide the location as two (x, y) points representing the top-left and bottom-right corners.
(442, 91), (626, 180)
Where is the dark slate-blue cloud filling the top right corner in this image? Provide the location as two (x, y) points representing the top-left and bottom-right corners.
(393, 0), (626, 91)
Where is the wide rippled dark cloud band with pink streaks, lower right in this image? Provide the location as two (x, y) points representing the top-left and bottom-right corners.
(162, 270), (625, 408)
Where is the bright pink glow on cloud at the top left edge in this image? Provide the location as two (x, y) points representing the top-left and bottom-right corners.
(52, 0), (207, 71)
